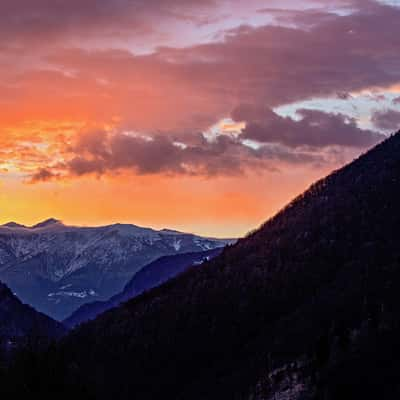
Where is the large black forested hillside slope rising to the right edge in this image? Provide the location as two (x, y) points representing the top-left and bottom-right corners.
(1, 134), (400, 400)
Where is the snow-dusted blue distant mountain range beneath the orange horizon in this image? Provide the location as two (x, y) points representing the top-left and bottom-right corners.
(0, 219), (229, 320)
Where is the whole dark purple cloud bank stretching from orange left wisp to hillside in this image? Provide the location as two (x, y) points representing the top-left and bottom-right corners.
(28, 112), (385, 182)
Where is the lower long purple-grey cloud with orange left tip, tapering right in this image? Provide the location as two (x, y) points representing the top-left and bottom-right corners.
(31, 131), (340, 182)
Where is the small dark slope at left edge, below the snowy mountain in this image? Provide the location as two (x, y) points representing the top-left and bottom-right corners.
(0, 282), (66, 353)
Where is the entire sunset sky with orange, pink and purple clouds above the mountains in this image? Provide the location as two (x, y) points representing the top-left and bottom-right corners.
(0, 0), (400, 237)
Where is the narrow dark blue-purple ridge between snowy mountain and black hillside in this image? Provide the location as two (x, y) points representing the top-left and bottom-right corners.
(63, 248), (222, 328)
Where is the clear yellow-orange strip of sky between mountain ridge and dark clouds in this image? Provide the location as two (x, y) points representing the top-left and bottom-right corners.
(0, 161), (332, 237)
